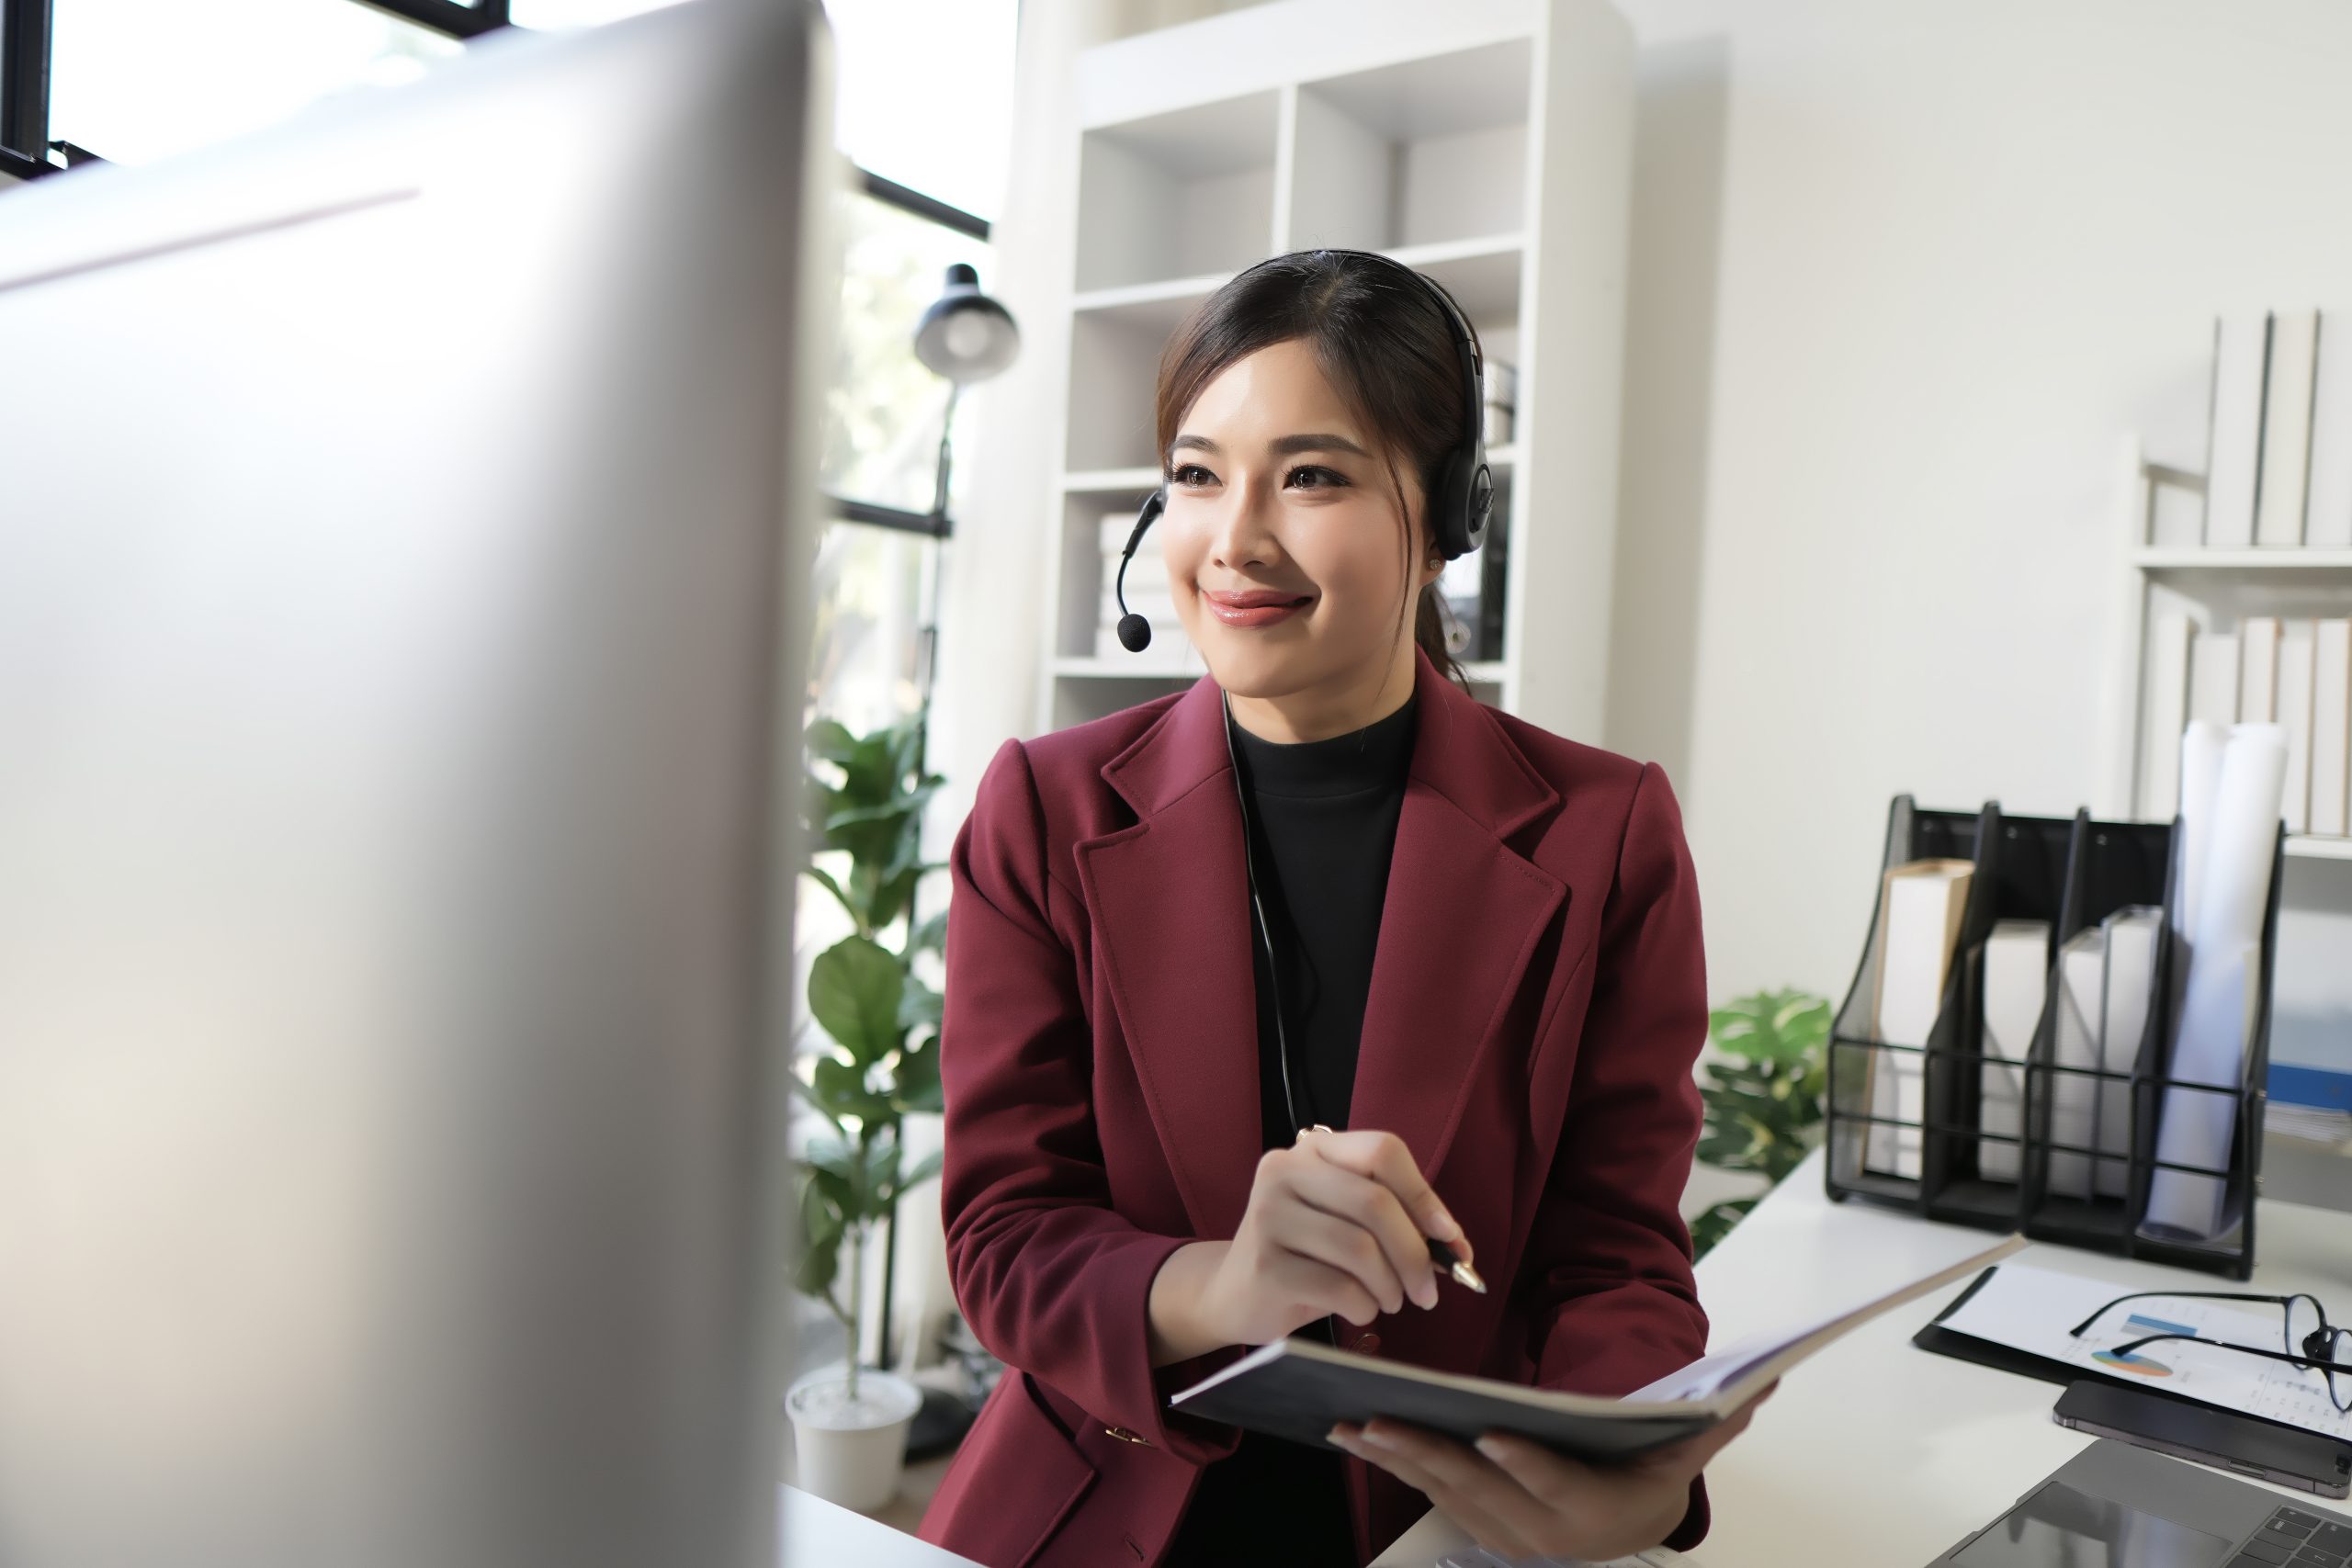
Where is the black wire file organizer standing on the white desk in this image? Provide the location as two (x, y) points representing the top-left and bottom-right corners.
(1826, 795), (2284, 1279)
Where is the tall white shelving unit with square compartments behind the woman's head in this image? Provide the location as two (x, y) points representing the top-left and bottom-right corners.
(1037, 0), (1633, 739)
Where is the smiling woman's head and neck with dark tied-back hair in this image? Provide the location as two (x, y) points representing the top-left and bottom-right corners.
(1158, 252), (1477, 740)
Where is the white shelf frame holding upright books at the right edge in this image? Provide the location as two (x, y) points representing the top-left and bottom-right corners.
(2093, 434), (2352, 861)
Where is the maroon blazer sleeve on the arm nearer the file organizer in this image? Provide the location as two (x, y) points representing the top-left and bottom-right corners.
(1521, 764), (1710, 1551)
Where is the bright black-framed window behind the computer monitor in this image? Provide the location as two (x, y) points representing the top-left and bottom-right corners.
(18, 0), (1018, 728)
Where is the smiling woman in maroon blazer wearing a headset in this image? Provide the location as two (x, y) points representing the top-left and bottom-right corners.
(922, 252), (1755, 1568)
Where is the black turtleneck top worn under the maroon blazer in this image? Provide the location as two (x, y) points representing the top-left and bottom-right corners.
(1162, 698), (1414, 1568)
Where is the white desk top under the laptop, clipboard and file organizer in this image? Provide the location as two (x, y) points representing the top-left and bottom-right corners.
(1378, 1149), (2352, 1568)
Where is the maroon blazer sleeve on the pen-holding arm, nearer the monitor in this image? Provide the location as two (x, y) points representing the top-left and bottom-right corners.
(938, 740), (1239, 1462)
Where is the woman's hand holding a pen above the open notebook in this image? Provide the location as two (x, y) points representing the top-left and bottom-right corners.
(1193, 1128), (1470, 1345)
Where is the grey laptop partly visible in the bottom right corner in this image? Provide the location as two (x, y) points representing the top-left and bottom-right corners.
(1928, 1438), (2352, 1568)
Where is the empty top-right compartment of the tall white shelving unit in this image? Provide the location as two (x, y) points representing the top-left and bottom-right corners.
(1289, 38), (1536, 252)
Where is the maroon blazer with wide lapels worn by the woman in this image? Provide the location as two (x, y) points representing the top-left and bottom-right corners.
(922, 651), (1708, 1568)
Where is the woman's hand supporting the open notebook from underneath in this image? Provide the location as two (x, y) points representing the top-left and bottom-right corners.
(1329, 1382), (1781, 1563)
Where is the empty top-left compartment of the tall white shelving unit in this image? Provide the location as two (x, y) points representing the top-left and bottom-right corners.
(1075, 92), (1282, 294)
